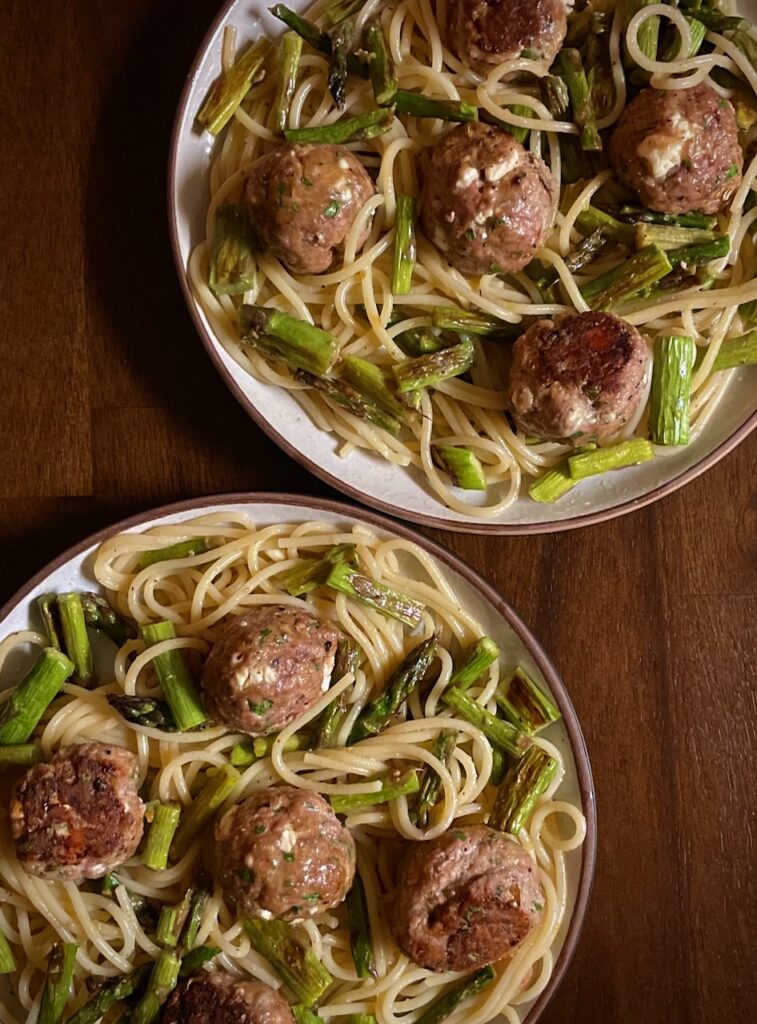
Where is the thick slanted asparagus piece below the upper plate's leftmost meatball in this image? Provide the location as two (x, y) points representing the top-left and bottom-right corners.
(240, 305), (339, 377)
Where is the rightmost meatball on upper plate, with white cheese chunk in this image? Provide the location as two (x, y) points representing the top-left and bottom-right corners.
(609, 84), (744, 213)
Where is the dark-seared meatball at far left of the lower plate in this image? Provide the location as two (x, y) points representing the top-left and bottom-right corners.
(10, 743), (144, 880)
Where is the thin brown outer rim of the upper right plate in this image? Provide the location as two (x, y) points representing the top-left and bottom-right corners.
(167, 0), (757, 537)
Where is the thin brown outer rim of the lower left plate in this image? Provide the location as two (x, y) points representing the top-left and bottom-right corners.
(0, 492), (597, 1024)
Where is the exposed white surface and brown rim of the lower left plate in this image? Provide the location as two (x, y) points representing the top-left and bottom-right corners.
(0, 495), (596, 1024)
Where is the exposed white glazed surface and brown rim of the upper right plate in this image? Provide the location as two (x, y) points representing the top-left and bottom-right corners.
(168, 0), (757, 534)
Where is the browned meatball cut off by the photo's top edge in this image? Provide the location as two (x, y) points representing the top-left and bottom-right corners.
(449, 0), (567, 65)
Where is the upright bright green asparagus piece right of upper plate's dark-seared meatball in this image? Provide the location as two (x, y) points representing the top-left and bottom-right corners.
(649, 335), (697, 444)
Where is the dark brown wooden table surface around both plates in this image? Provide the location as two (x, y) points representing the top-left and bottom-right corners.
(0, 0), (757, 1024)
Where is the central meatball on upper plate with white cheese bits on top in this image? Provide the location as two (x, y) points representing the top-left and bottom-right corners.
(421, 122), (555, 274)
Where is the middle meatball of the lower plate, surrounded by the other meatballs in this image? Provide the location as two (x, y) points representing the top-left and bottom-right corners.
(215, 785), (354, 921)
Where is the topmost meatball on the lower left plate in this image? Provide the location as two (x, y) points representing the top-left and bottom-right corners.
(202, 605), (340, 736)
